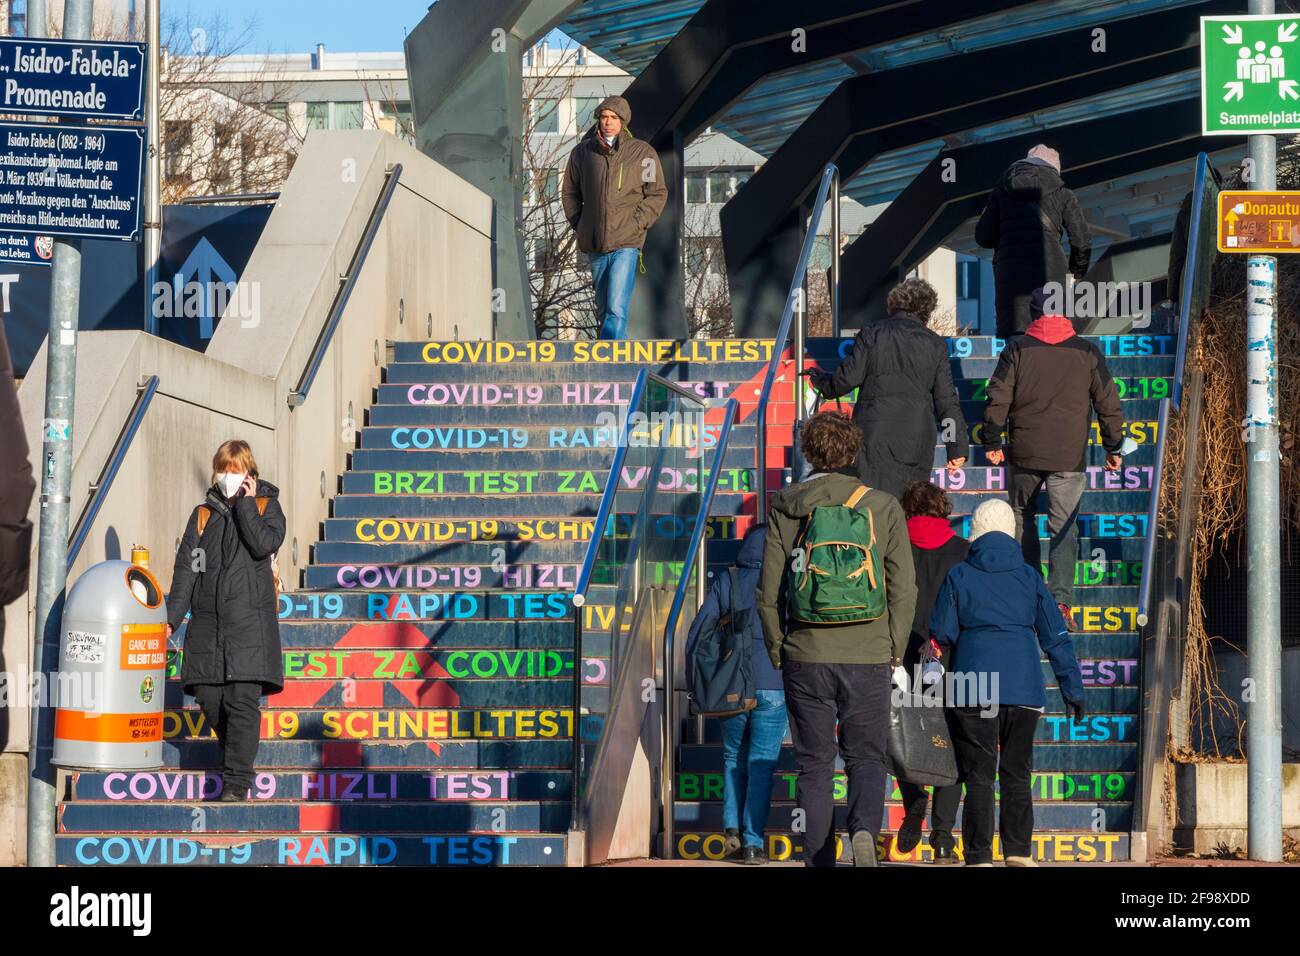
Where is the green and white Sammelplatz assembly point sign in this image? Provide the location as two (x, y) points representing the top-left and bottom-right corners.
(1201, 14), (1300, 137)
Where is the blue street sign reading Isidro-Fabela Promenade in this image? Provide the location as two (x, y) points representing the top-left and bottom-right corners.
(0, 36), (147, 120)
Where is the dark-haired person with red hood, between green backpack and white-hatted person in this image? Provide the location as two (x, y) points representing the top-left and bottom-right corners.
(894, 481), (971, 864)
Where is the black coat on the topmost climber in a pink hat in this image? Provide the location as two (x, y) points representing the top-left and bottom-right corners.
(975, 159), (1092, 338)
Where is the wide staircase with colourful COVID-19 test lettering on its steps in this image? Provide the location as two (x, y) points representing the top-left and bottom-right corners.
(56, 336), (1174, 866)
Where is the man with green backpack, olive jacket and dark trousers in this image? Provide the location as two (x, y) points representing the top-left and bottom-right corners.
(757, 411), (917, 866)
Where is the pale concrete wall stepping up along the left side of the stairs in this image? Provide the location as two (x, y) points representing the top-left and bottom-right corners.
(0, 130), (491, 865)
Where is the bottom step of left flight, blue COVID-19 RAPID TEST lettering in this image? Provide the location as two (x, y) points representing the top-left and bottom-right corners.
(55, 832), (564, 866)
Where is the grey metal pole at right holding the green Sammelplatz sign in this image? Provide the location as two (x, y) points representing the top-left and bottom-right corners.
(1244, 0), (1282, 862)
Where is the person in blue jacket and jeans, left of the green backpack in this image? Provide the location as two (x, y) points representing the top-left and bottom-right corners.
(686, 524), (787, 865)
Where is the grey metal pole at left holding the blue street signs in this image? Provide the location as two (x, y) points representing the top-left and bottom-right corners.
(27, 0), (92, 866)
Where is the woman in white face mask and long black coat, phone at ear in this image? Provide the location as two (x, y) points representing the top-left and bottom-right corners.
(166, 440), (285, 803)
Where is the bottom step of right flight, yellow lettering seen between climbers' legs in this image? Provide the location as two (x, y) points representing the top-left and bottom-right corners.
(675, 831), (1130, 865)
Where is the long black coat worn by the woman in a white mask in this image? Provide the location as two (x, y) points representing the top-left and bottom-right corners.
(166, 479), (285, 693)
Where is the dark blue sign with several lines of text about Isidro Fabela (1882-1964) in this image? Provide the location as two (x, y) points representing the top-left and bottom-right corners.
(0, 122), (144, 242)
